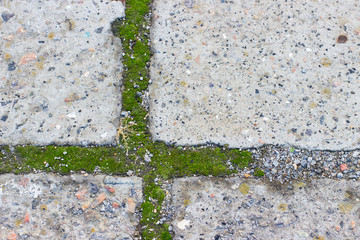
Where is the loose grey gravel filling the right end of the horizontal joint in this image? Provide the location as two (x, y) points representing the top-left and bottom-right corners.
(243, 145), (360, 183)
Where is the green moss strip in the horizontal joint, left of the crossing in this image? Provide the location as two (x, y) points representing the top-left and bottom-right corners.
(0, 146), (139, 175)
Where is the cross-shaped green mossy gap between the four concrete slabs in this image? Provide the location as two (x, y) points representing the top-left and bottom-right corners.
(0, 0), (253, 239)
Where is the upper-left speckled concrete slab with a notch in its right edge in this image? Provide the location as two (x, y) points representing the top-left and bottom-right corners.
(0, 0), (125, 145)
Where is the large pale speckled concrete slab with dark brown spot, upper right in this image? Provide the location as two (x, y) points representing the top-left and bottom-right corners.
(150, 0), (360, 150)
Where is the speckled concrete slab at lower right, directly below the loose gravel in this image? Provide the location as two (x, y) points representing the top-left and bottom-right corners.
(172, 177), (360, 240)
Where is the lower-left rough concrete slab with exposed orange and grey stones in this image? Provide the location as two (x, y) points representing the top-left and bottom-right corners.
(0, 174), (142, 240)
